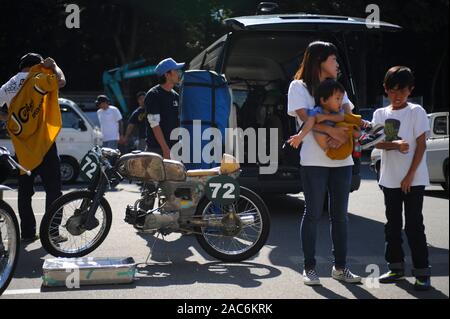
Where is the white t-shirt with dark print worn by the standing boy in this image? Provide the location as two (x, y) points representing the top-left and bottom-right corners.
(372, 103), (430, 188)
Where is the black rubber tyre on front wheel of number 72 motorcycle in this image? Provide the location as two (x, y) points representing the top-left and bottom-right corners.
(39, 191), (112, 258)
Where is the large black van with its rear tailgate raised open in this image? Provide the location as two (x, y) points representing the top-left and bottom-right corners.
(189, 14), (400, 193)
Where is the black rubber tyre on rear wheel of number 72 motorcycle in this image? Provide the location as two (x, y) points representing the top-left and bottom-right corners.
(195, 187), (270, 262)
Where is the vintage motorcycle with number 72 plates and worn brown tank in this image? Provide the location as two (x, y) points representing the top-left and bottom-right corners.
(40, 147), (270, 262)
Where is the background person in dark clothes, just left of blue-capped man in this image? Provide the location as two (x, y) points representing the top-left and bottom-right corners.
(120, 91), (147, 151)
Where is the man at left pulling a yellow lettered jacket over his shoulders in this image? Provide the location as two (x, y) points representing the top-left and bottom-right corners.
(0, 53), (67, 242)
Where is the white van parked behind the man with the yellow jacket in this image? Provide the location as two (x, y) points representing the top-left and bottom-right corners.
(0, 98), (102, 183)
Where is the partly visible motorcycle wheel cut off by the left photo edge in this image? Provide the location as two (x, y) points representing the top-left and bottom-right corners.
(0, 201), (20, 296)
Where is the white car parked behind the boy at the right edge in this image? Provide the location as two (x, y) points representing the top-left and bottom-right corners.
(371, 112), (449, 190)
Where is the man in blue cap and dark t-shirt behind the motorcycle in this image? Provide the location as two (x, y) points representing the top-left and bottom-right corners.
(144, 58), (185, 159)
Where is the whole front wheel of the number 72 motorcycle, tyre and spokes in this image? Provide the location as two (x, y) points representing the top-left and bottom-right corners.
(40, 191), (112, 258)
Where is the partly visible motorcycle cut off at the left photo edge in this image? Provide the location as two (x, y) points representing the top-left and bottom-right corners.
(0, 147), (24, 296)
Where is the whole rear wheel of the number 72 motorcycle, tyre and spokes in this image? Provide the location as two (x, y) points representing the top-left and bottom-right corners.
(196, 187), (270, 262)
